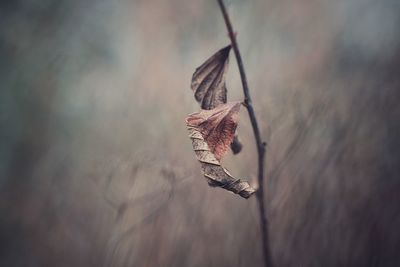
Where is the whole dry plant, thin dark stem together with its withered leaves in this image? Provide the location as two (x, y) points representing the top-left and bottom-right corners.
(186, 0), (273, 267)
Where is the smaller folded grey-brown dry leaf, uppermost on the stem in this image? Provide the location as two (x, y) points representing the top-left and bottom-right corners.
(191, 45), (231, 109)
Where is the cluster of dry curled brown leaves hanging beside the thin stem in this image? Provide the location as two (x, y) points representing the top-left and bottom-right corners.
(186, 46), (255, 198)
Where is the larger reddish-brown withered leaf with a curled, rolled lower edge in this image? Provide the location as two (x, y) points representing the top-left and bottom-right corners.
(186, 102), (255, 198)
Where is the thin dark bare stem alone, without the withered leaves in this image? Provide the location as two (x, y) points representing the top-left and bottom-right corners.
(217, 0), (273, 267)
